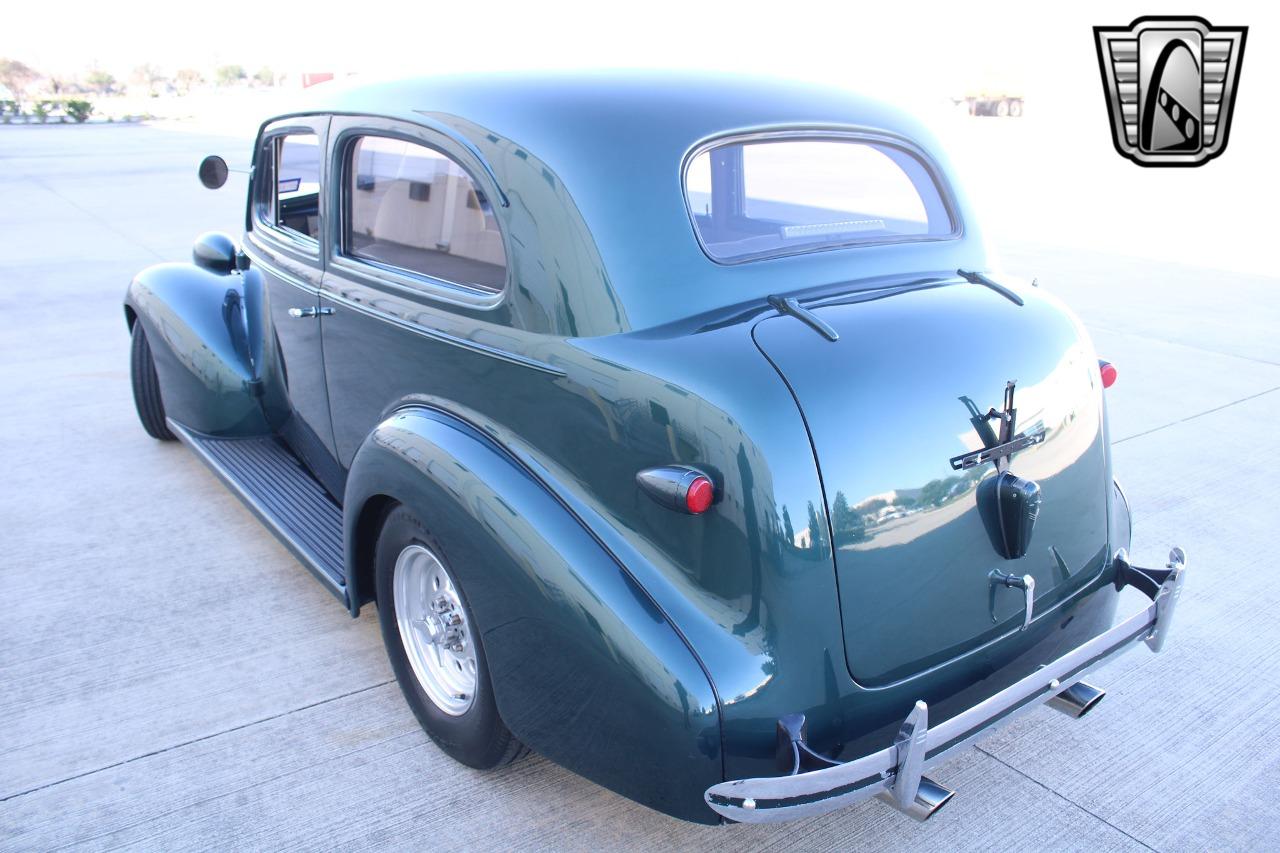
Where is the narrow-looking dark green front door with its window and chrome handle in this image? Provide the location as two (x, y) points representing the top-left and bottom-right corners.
(244, 117), (343, 498)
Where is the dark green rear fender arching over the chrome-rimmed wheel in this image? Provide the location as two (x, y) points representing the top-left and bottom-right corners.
(344, 409), (723, 822)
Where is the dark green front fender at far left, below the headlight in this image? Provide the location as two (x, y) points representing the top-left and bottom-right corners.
(124, 264), (270, 435)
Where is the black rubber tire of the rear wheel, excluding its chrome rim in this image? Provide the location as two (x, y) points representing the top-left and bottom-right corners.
(374, 506), (527, 770)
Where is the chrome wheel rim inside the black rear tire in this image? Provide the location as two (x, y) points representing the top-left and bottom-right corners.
(392, 544), (476, 717)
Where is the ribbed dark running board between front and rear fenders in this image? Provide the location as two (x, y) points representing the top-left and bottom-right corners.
(166, 419), (347, 605)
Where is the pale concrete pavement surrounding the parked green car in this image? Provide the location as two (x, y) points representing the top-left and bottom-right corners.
(0, 126), (1280, 850)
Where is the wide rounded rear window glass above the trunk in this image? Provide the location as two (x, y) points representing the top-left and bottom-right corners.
(685, 137), (955, 263)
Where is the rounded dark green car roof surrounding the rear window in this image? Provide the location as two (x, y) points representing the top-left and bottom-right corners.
(294, 70), (984, 328)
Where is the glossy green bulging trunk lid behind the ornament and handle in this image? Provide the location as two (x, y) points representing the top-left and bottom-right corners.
(754, 282), (1110, 686)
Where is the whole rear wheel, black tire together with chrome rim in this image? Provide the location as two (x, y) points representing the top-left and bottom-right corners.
(375, 506), (525, 770)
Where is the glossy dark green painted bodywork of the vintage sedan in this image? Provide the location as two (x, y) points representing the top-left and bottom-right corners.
(127, 76), (1128, 822)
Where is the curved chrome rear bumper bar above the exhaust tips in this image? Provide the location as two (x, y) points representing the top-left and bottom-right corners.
(704, 548), (1187, 824)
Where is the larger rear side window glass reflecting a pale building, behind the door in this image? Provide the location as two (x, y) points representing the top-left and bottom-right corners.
(343, 136), (507, 292)
